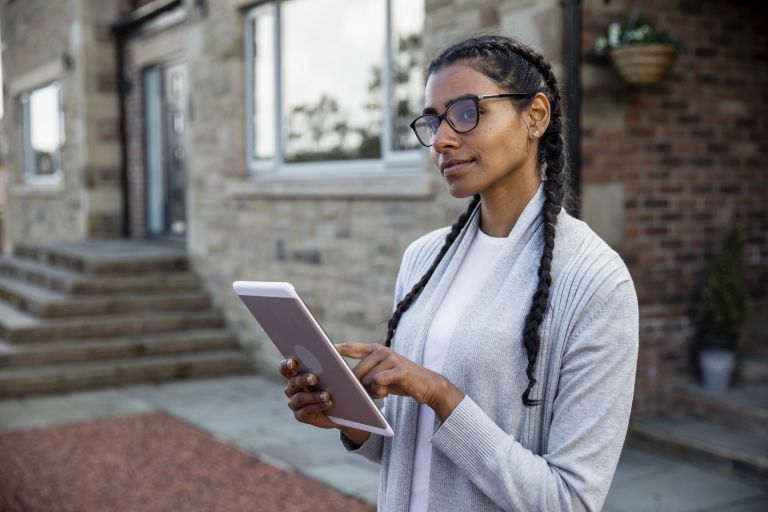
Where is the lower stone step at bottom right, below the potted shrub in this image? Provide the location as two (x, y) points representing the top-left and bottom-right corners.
(629, 418), (768, 486)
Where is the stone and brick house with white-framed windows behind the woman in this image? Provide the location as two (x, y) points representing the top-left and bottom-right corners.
(0, 0), (768, 424)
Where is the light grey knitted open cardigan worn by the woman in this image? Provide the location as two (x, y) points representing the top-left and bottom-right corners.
(342, 188), (638, 512)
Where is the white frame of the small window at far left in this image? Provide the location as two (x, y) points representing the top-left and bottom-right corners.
(18, 80), (66, 185)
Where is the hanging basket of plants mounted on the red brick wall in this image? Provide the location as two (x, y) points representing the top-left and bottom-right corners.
(595, 8), (682, 85)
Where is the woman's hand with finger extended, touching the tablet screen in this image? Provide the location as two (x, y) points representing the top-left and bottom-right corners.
(336, 343), (464, 420)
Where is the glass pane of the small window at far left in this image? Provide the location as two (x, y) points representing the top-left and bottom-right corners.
(24, 84), (63, 176)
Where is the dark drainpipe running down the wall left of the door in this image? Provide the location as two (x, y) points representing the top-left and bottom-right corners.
(112, 0), (181, 238)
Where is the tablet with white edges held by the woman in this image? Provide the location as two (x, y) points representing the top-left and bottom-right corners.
(232, 281), (394, 437)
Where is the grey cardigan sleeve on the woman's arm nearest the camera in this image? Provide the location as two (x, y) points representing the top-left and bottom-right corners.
(431, 280), (638, 511)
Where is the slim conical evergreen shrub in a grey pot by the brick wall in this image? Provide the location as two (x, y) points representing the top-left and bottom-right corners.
(698, 224), (748, 392)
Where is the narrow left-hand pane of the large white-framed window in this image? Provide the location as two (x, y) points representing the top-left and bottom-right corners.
(252, 11), (276, 158)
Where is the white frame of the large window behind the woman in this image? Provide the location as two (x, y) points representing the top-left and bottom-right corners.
(244, 0), (424, 179)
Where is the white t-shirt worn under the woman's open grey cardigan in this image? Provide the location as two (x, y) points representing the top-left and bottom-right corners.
(409, 229), (507, 512)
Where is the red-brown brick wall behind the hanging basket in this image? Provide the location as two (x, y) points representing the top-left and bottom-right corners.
(582, 0), (768, 408)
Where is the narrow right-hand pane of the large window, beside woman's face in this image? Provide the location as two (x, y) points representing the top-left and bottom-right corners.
(392, 0), (425, 150)
